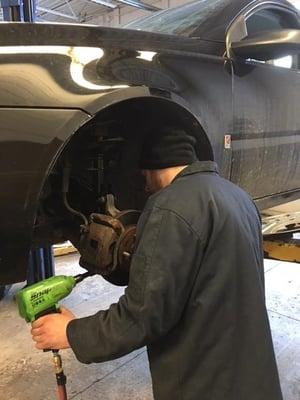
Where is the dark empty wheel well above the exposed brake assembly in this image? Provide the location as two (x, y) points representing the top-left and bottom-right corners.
(34, 97), (214, 247)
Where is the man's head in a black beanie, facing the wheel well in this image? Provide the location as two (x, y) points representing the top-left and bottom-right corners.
(140, 127), (197, 193)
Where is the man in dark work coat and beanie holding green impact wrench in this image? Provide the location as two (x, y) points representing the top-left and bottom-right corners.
(32, 127), (282, 400)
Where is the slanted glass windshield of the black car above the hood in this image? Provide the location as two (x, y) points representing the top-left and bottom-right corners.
(124, 0), (227, 36)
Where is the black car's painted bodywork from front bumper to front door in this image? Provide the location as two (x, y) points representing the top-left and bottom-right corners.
(0, 0), (300, 283)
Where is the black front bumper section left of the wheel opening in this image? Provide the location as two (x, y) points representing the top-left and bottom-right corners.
(0, 108), (89, 283)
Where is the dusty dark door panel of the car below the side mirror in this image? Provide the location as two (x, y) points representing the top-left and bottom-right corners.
(231, 60), (300, 199)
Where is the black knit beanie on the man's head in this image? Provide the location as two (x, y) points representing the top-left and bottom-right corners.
(139, 127), (197, 170)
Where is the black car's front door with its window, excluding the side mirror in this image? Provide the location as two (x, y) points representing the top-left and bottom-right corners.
(227, 2), (300, 203)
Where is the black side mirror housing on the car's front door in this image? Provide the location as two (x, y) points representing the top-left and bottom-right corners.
(231, 29), (300, 61)
